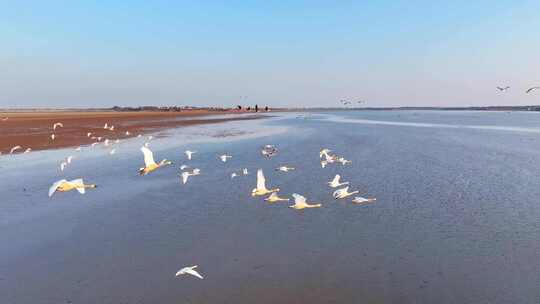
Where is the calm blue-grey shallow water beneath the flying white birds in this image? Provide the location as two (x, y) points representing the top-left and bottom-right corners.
(0, 111), (540, 303)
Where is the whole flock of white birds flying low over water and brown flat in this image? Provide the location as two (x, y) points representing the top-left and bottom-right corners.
(5, 118), (376, 279)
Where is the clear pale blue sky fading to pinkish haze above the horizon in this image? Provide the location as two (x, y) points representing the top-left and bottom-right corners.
(0, 0), (540, 107)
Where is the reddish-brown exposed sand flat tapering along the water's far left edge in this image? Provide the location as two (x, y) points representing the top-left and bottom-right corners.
(0, 110), (263, 154)
